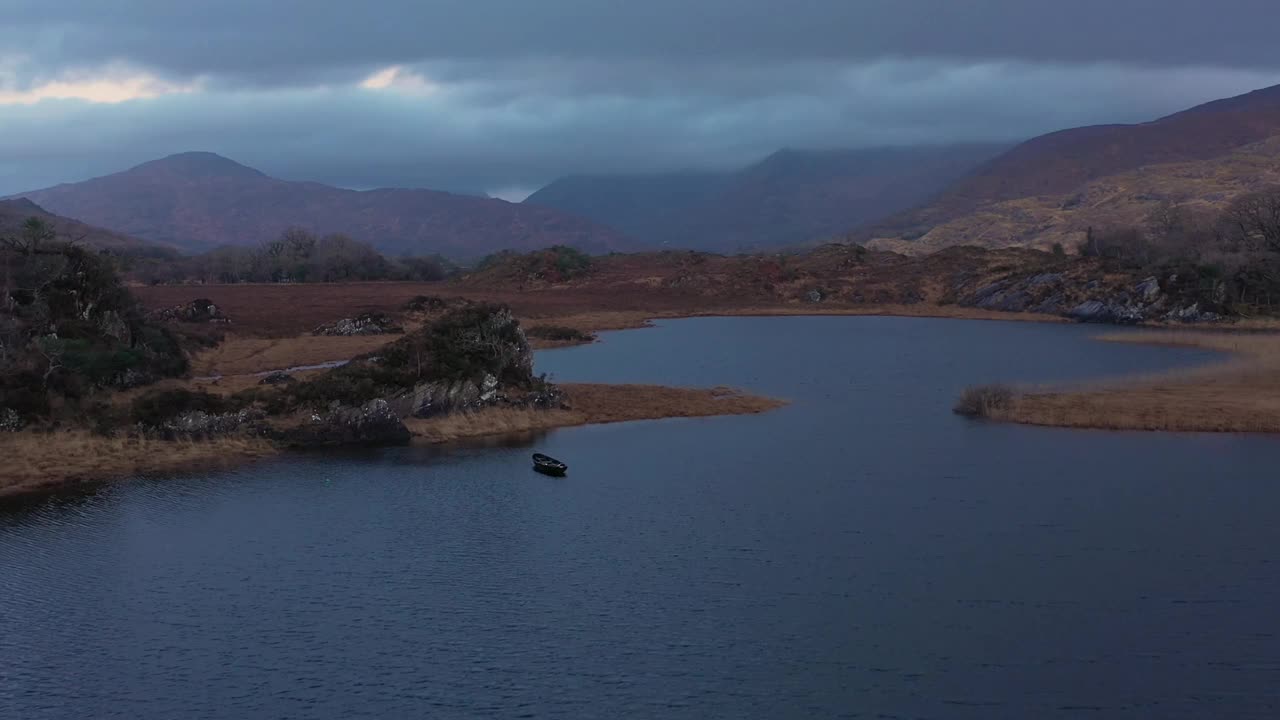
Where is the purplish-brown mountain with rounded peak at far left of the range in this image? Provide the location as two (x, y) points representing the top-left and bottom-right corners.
(10, 152), (630, 258)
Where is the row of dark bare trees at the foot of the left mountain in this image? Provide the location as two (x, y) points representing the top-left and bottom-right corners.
(127, 228), (457, 284)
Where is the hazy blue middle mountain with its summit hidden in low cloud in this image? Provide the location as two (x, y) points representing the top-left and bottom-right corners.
(525, 145), (1006, 251)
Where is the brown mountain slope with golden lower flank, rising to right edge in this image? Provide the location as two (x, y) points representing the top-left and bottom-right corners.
(863, 86), (1280, 250)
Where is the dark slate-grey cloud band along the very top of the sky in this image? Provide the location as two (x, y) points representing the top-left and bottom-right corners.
(5, 0), (1280, 77)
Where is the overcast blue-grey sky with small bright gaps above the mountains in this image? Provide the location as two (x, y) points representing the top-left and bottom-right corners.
(0, 0), (1280, 197)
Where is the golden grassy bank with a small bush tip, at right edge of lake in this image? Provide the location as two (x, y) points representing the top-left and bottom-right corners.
(956, 331), (1280, 433)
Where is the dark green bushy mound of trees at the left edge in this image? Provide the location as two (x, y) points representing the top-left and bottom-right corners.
(0, 218), (187, 424)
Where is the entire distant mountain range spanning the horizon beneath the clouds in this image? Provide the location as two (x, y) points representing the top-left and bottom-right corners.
(10, 86), (1280, 259)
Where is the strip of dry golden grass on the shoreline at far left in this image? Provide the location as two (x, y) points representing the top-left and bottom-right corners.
(0, 430), (275, 498)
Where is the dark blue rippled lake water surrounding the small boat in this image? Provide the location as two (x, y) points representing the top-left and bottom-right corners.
(0, 318), (1280, 720)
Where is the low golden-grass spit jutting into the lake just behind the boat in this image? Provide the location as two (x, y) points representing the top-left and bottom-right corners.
(404, 383), (785, 443)
